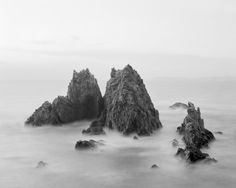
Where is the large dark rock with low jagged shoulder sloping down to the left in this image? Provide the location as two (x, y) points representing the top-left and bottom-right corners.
(26, 69), (103, 126)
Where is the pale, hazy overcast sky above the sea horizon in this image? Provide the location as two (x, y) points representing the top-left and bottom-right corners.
(0, 0), (236, 80)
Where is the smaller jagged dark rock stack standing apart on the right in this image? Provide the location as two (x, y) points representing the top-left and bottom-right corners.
(177, 102), (215, 162)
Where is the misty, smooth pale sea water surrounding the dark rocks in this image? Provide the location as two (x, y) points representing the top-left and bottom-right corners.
(0, 79), (236, 188)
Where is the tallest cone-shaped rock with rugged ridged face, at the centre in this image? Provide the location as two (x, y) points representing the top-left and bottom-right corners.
(83, 65), (162, 135)
